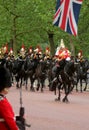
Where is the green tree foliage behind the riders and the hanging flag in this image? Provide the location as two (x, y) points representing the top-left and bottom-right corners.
(0, 0), (89, 56)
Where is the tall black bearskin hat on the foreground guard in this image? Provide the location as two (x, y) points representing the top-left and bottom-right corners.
(0, 67), (11, 91)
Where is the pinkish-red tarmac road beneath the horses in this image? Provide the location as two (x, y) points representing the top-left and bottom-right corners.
(7, 86), (89, 130)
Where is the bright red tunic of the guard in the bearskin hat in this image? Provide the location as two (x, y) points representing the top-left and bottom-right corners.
(0, 96), (18, 130)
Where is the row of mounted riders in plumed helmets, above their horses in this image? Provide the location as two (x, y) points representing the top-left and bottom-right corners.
(0, 39), (83, 62)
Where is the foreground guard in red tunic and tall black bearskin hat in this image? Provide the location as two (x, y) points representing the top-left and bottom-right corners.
(0, 67), (19, 130)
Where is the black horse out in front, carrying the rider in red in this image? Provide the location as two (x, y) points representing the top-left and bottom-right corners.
(50, 59), (76, 102)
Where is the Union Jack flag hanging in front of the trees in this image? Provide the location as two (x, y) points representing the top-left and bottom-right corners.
(53, 0), (83, 36)
